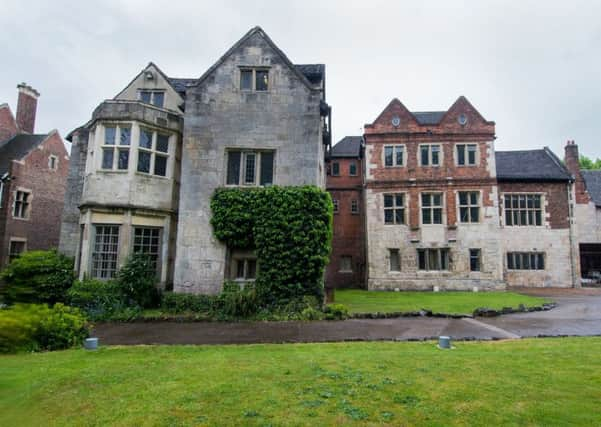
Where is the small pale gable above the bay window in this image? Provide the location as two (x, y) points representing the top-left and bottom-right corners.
(114, 62), (184, 112)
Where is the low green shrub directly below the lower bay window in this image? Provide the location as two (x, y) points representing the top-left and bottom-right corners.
(67, 279), (132, 320)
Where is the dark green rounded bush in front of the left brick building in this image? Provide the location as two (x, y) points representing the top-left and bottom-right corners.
(0, 250), (75, 304)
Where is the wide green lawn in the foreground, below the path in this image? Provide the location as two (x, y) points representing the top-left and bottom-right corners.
(0, 338), (601, 426)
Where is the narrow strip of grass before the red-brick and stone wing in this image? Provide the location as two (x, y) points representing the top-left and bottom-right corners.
(334, 289), (550, 314)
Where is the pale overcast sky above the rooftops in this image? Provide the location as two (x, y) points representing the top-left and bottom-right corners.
(0, 0), (601, 157)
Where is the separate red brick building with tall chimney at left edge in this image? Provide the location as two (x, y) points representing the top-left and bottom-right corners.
(0, 84), (69, 267)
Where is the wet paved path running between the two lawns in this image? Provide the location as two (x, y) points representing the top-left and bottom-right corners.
(94, 291), (601, 344)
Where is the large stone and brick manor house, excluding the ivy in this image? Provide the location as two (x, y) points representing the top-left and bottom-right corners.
(60, 27), (601, 293)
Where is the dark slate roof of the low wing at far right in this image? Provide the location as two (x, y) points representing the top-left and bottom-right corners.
(495, 147), (572, 182)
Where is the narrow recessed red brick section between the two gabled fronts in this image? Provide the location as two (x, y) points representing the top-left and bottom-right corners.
(326, 136), (366, 288)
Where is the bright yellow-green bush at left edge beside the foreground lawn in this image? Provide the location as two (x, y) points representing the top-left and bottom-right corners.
(0, 303), (89, 353)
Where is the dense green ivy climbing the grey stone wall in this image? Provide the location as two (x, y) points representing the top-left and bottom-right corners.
(211, 186), (333, 305)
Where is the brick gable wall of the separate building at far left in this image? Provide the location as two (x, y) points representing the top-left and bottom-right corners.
(0, 132), (69, 265)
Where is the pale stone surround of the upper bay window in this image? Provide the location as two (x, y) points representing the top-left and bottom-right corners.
(93, 120), (176, 179)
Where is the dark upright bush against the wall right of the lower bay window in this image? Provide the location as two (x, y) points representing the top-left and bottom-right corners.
(116, 253), (160, 308)
